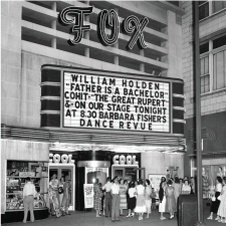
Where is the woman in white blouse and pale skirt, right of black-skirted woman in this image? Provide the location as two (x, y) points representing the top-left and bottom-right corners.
(134, 180), (146, 220)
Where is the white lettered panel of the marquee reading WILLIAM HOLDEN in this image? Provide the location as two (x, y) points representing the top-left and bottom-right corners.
(63, 71), (170, 132)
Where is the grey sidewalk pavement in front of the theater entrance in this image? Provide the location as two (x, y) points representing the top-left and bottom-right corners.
(3, 200), (223, 226)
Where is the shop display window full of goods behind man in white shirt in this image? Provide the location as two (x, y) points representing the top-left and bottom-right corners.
(6, 161), (48, 211)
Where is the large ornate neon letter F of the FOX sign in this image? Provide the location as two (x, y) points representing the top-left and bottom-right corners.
(59, 6), (93, 45)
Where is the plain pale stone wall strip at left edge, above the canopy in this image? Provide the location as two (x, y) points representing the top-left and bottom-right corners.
(1, 1), (22, 125)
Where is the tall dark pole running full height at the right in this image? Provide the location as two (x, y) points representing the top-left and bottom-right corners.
(193, 1), (206, 226)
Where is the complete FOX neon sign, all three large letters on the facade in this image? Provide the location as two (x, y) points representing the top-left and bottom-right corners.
(59, 6), (149, 50)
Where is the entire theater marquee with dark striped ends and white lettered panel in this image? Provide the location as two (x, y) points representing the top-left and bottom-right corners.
(41, 65), (184, 135)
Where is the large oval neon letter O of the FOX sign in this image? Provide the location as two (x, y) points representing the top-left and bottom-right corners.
(98, 9), (119, 46)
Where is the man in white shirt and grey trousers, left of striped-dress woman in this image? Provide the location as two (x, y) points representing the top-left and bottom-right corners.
(111, 176), (120, 222)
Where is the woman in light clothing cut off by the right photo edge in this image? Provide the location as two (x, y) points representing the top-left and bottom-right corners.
(217, 177), (226, 224)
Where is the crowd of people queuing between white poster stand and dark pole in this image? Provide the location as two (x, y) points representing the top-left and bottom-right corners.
(94, 176), (202, 221)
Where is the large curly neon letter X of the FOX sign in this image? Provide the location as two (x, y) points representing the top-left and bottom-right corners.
(124, 15), (149, 50)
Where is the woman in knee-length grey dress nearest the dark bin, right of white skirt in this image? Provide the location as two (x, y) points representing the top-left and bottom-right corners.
(166, 180), (177, 220)
